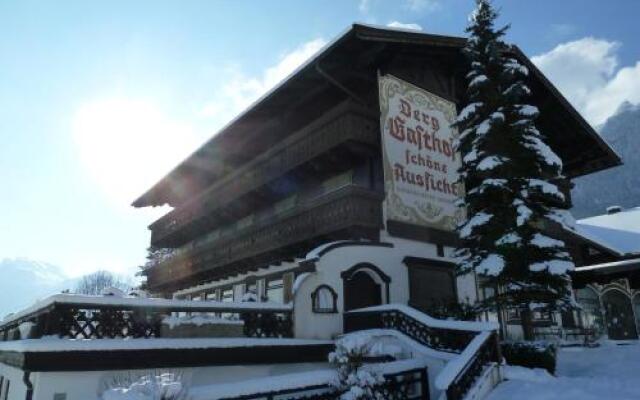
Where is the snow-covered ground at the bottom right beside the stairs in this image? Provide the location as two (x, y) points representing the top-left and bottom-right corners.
(487, 343), (640, 400)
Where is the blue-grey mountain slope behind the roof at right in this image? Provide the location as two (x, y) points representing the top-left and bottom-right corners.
(571, 103), (640, 218)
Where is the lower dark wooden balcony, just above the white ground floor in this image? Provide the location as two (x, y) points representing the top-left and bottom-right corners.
(145, 185), (383, 291)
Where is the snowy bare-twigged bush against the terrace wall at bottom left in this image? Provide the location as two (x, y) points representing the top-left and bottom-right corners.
(102, 372), (187, 400)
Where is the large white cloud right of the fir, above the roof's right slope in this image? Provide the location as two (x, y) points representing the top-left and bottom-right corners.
(532, 37), (640, 125)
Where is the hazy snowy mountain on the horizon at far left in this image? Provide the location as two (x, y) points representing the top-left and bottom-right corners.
(0, 258), (74, 320)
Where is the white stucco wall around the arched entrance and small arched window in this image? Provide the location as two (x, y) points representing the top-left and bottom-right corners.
(294, 232), (476, 339)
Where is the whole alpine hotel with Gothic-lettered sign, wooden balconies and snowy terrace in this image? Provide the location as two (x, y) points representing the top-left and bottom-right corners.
(0, 25), (640, 400)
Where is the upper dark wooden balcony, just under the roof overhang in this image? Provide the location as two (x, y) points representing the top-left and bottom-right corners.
(149, 103), (379, 247)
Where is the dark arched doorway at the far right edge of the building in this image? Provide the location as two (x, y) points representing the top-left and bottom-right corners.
(602, 289), (638, 340)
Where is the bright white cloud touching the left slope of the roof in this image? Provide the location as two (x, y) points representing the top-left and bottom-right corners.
(201, 39), (327, 123)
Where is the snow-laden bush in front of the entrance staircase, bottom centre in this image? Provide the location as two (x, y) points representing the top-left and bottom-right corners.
(329, 334), (386, 400)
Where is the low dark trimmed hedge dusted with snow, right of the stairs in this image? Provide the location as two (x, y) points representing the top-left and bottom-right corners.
(500, 342), (556, 375)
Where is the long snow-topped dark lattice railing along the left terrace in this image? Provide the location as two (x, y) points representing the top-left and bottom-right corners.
(0, 294), (293, 341)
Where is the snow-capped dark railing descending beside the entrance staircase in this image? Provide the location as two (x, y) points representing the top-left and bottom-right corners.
(344, 304), (501, 400)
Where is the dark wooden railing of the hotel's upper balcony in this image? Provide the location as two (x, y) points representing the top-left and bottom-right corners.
(150, 107), (379, 245)
